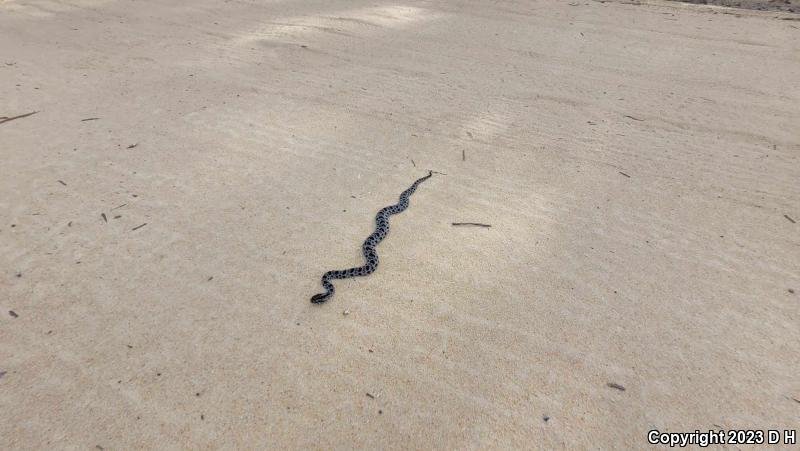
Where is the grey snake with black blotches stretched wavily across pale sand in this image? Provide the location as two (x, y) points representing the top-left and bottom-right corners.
(311, 171), (433, 304)
